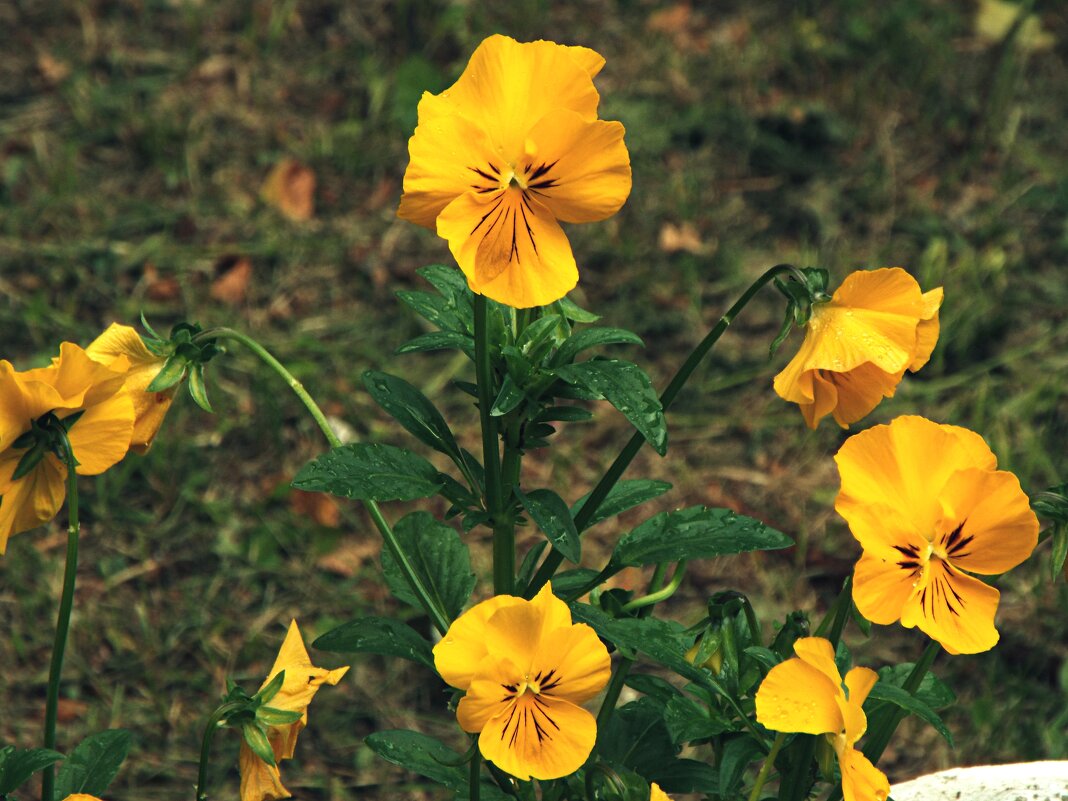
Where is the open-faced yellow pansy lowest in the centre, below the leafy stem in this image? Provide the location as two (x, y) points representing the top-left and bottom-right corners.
(434, 584), (611, 781)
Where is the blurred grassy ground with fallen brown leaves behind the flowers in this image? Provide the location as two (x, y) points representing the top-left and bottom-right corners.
(0, 0), (1068, 801)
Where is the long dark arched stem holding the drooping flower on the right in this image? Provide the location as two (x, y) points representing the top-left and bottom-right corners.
(524, 264), (807, 598)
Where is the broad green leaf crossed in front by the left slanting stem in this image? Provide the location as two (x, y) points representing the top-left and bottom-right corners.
(382, 512), (475, 618)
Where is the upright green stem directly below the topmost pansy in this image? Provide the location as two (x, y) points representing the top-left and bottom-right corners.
(474, 295), (516, 595)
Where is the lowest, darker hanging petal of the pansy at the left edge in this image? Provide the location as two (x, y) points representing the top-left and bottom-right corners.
(0, 452), (66, 553)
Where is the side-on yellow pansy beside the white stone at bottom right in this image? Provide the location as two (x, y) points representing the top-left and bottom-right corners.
(756, 637), (890, 801)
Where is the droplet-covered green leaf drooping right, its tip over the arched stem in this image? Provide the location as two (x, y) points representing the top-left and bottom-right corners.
(553, 359), (668, 456)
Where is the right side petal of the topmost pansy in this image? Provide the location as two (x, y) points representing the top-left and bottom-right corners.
(525, 109), (630, 222)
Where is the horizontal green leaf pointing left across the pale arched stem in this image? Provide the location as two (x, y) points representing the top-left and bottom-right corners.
(293, 442), (444, 501)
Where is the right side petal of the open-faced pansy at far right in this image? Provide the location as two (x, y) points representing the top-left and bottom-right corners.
(937, 468), (1038, 576)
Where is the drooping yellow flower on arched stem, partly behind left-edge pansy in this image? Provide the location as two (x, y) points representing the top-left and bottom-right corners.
(85, 323), (177, 454)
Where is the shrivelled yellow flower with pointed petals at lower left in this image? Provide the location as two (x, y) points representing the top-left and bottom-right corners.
(238, 621), (348, 801)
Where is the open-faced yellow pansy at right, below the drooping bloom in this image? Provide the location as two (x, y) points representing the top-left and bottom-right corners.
(834, 417), (1038, 654)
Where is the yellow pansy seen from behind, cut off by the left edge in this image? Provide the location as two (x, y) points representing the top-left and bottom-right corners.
(0, 342), (134, 553)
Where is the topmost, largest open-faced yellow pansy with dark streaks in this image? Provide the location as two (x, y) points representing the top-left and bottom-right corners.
(397, 35), (630, 308)
